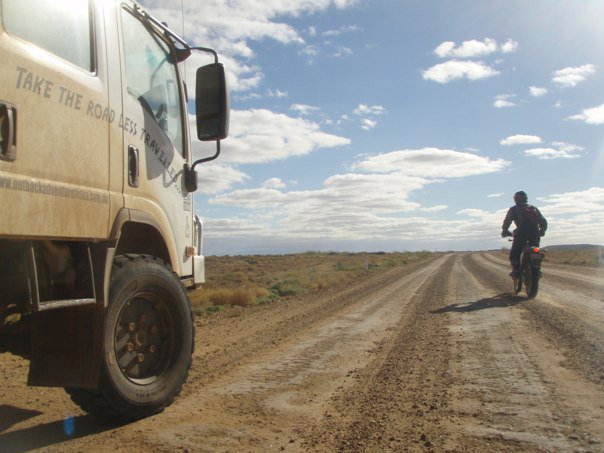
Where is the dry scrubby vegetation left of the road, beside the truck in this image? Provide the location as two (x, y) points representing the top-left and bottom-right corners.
(191, 252), (431, 314)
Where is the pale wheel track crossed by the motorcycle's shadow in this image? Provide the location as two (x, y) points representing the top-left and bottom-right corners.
(447, 255), (604, 451)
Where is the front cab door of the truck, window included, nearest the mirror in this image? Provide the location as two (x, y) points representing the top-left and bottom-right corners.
(120, 6), (193, 276)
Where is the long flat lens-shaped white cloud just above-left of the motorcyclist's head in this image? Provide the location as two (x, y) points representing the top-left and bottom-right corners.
(353, 148), (509, 178)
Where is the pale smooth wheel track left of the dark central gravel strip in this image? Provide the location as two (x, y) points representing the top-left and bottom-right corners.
(139, 254), (452, 451)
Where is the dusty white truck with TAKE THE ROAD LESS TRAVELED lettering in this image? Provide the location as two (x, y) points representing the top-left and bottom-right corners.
(0, 0), (229, 419)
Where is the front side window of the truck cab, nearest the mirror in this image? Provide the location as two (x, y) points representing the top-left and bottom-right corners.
(122, 10), (184, 155)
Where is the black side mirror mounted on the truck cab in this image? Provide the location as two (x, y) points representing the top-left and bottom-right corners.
(195, 63), (230, 141)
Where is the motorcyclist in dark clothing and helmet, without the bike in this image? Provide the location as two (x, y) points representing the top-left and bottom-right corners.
(501, 190), (547, 277)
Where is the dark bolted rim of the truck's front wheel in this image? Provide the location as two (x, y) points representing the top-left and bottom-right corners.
(115, 293), (174, 385)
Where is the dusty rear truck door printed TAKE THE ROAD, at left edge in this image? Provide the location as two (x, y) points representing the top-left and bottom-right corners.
(0, 0), (114, 239)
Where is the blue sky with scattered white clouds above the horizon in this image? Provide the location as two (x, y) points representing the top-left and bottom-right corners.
(142, 0), (604, 255)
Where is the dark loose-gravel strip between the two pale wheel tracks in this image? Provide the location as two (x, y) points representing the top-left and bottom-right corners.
(305, 256), (455, 451)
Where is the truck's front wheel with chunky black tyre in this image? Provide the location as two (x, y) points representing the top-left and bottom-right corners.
(67, 255), (195, 420)
